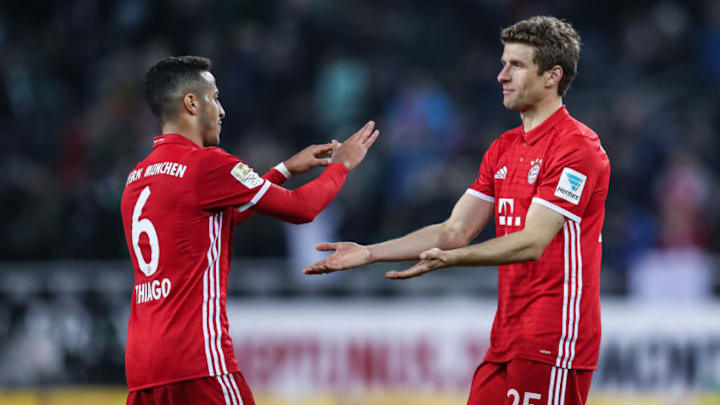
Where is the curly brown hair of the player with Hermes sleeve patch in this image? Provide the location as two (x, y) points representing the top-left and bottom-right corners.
(500, 16), (580, 97)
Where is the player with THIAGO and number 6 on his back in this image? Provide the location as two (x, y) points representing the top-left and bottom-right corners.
(121, 56), (378, 405)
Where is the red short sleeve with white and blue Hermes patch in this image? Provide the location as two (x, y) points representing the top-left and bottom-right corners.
(532, 141), (607, 222)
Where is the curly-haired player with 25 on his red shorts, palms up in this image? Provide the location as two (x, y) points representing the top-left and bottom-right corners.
(305, 17), (610, 405)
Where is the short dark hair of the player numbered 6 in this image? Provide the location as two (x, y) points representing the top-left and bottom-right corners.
(145, 56), (212, 120)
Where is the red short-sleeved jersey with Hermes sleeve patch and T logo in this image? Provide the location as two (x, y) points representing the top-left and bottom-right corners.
(467, 106), (610, 369)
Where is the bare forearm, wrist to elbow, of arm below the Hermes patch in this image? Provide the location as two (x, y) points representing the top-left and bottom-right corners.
(446, 231), (545, 266)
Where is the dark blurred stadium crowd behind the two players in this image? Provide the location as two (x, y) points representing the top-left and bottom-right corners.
(0, 0), (720, 288)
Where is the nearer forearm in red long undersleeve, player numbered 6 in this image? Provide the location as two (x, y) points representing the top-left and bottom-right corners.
(255, 163), (348, 224)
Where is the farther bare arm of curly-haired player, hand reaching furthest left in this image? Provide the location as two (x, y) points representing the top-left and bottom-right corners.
(303, 194), (493, 274)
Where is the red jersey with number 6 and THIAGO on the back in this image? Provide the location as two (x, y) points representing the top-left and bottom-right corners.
(121, 134), (347, 391)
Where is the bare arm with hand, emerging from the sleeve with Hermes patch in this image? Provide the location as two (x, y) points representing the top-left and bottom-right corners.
(385, 204), (565, 279)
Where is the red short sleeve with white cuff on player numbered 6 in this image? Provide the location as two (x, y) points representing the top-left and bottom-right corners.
(195, 148), (270, 211)
